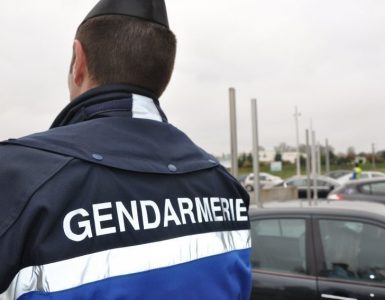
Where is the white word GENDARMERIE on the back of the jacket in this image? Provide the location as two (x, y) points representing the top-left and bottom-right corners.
(63, 197), (248, 242)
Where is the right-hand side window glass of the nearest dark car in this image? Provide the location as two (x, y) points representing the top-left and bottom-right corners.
(319, 220), (385, 283)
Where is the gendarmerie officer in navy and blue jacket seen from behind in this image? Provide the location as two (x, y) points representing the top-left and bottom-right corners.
(0, 0), (251, 300)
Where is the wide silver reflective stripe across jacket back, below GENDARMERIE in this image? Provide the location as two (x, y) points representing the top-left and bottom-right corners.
(0, 230), (251, 300)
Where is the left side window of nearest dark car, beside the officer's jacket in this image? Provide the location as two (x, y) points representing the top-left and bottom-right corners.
(251, 219), (307, 274)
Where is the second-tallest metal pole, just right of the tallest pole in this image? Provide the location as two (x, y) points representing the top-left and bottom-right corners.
(251, 99), (263, 207)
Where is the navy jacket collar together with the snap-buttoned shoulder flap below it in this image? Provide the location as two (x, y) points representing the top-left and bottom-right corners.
(5, 85), (218, 174)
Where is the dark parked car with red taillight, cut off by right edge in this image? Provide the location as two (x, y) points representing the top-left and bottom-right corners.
(328, 177), (385, 204)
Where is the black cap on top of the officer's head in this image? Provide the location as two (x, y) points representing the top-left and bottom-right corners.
(82, 0), (169, 28)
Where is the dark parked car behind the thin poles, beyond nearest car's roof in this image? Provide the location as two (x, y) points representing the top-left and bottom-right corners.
(276, 176), (340, 198)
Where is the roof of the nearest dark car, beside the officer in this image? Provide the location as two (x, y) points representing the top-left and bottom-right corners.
(249, 200), (385, 222)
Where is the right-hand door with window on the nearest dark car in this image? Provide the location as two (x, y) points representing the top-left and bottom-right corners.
(313, 217), (385, 300)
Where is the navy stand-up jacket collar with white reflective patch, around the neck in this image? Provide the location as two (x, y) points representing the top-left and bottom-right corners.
(51, 84), (167, 128)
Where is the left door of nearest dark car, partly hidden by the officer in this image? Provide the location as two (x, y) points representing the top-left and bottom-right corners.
(251, 216), (317, 300)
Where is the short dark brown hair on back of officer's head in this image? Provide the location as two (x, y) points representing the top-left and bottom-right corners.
(75, 15), (176, 97)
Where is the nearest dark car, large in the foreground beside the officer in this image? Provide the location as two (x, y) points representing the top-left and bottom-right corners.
(250, 201), (385, 300)
